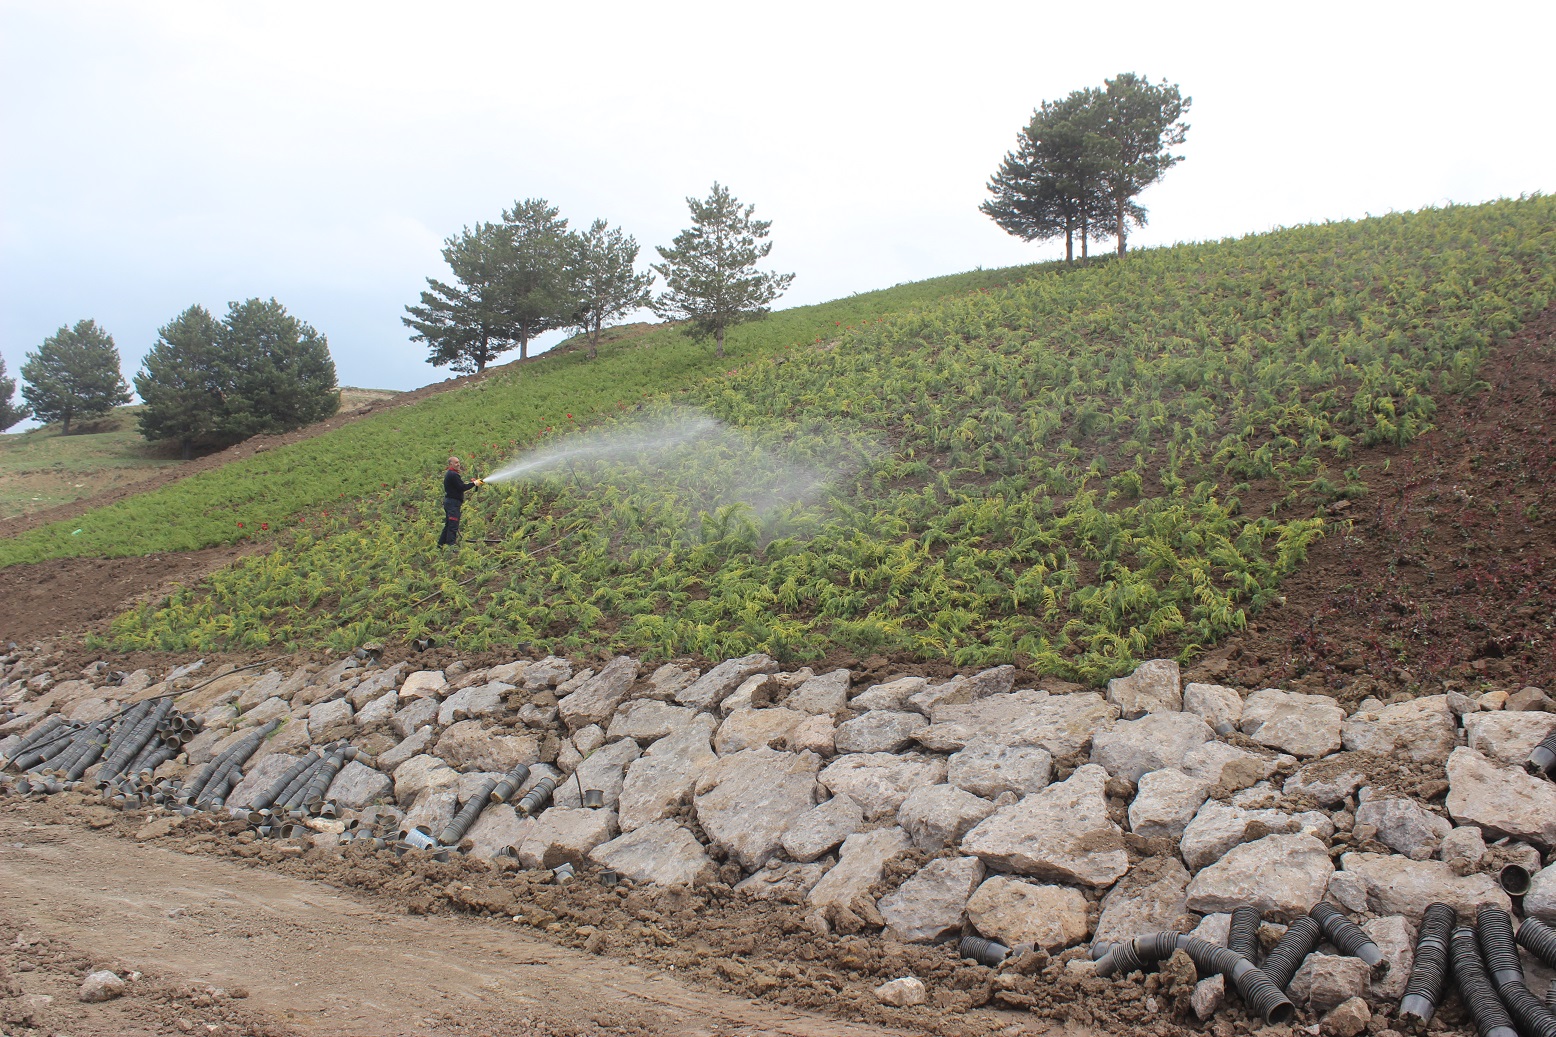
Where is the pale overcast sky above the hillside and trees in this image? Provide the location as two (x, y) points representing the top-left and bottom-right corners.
(0, 0), (1556, 420)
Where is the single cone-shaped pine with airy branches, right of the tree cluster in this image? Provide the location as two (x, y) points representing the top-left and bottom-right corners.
(652, 182), (794, 358)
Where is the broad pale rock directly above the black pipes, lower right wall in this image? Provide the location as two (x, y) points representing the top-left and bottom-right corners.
(1187, 835), (1335, 922)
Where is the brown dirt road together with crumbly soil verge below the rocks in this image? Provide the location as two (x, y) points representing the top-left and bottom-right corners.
(0, 794), (1120, 1037)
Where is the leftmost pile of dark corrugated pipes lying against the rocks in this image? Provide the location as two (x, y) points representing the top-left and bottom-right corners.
(0, 696), (201, 810)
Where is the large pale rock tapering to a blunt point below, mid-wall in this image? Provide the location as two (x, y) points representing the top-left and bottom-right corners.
(692, 746), (822, 870)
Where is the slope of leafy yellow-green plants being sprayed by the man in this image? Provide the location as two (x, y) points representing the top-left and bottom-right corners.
(103, 198), (1556, 680)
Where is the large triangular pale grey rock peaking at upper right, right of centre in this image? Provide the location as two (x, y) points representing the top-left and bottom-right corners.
(962, 765), (1130, 886)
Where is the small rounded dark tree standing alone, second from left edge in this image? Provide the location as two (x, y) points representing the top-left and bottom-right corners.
(22, 321), (129, 436)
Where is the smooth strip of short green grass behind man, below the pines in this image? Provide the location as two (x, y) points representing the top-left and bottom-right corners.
(0, 268), (1036, 568)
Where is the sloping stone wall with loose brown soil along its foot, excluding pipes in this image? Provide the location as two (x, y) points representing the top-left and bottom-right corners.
(0, 641), (1556, 1037)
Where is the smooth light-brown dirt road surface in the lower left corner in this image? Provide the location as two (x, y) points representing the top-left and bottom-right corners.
(0, 813), (927, 1037)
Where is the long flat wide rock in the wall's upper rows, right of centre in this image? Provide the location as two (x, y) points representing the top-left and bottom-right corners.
(918, 691), (1119, 757)
